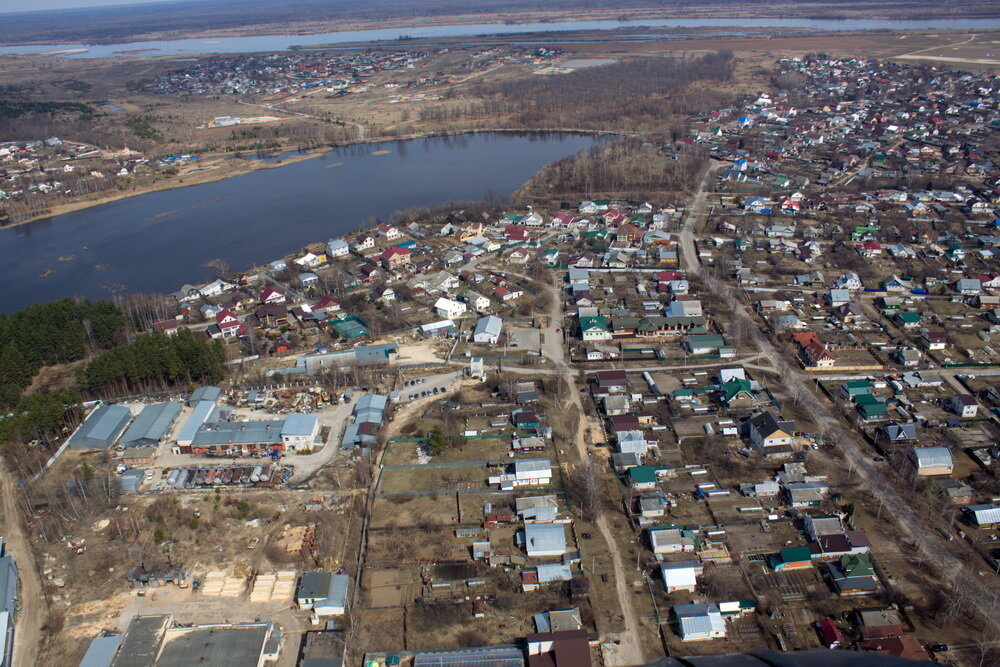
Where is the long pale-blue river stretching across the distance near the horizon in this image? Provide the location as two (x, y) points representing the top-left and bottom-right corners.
(0, 18), (1000, 58)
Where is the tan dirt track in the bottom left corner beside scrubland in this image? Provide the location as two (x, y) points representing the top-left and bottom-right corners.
(0, 460), (48, 667)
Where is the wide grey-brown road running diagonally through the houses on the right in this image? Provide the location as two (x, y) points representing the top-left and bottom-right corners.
(681, 160), (997, 624)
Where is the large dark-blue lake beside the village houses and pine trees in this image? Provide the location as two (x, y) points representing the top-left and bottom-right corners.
(0, 133), (599, 312)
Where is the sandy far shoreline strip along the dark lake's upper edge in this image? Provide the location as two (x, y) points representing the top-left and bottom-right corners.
(0, 128), (635, 232)
